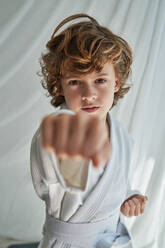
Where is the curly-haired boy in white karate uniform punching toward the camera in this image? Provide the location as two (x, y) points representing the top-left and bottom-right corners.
(31, 14), (147, 248)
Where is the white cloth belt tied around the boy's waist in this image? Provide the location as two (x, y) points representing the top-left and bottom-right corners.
(44, 214), (117, 247)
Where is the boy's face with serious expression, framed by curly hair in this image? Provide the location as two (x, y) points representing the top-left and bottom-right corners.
(61, 62), (120, 120)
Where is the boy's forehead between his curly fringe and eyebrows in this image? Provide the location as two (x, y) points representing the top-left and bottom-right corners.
(63, 62), (115, 79)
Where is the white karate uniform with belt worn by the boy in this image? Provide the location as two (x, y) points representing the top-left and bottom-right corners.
(30, 104), (141, 248)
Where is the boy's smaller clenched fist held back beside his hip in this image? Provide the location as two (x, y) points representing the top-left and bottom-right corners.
(120, 195), (148, 216)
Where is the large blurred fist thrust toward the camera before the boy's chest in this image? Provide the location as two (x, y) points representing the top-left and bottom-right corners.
(41, 113), (112, 167)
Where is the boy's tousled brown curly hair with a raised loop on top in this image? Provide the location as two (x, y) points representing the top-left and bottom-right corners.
(40, 14), (132, 107)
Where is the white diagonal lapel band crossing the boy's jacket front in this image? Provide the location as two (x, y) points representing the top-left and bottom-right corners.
(68, 112), (119, 222)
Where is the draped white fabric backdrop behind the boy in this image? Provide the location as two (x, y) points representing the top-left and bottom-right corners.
(0, 0), (165, 248)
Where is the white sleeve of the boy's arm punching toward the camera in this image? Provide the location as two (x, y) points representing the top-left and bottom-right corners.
(30, 111), (89, 200)
